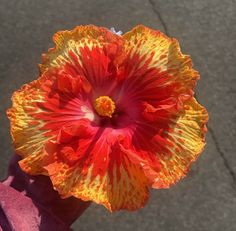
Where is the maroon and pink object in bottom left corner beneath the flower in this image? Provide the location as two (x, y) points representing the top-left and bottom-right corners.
(0, 155), (90, 231)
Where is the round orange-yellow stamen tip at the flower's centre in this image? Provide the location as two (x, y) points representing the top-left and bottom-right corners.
(94, 96), (116, 117)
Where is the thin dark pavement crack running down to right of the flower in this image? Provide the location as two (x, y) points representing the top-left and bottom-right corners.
(207, 125), (236, 189)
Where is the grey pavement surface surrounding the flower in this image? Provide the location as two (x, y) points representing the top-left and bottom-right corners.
(0, 0), (236, 231)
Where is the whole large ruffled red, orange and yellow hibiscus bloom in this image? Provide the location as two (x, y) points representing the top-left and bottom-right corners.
(8, 26), (208, 211)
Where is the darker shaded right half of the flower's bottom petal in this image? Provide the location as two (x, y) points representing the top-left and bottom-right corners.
(108, 145), (149, 211)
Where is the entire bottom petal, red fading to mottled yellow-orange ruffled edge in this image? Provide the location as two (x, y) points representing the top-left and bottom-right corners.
(45, 134), (149, 211)
